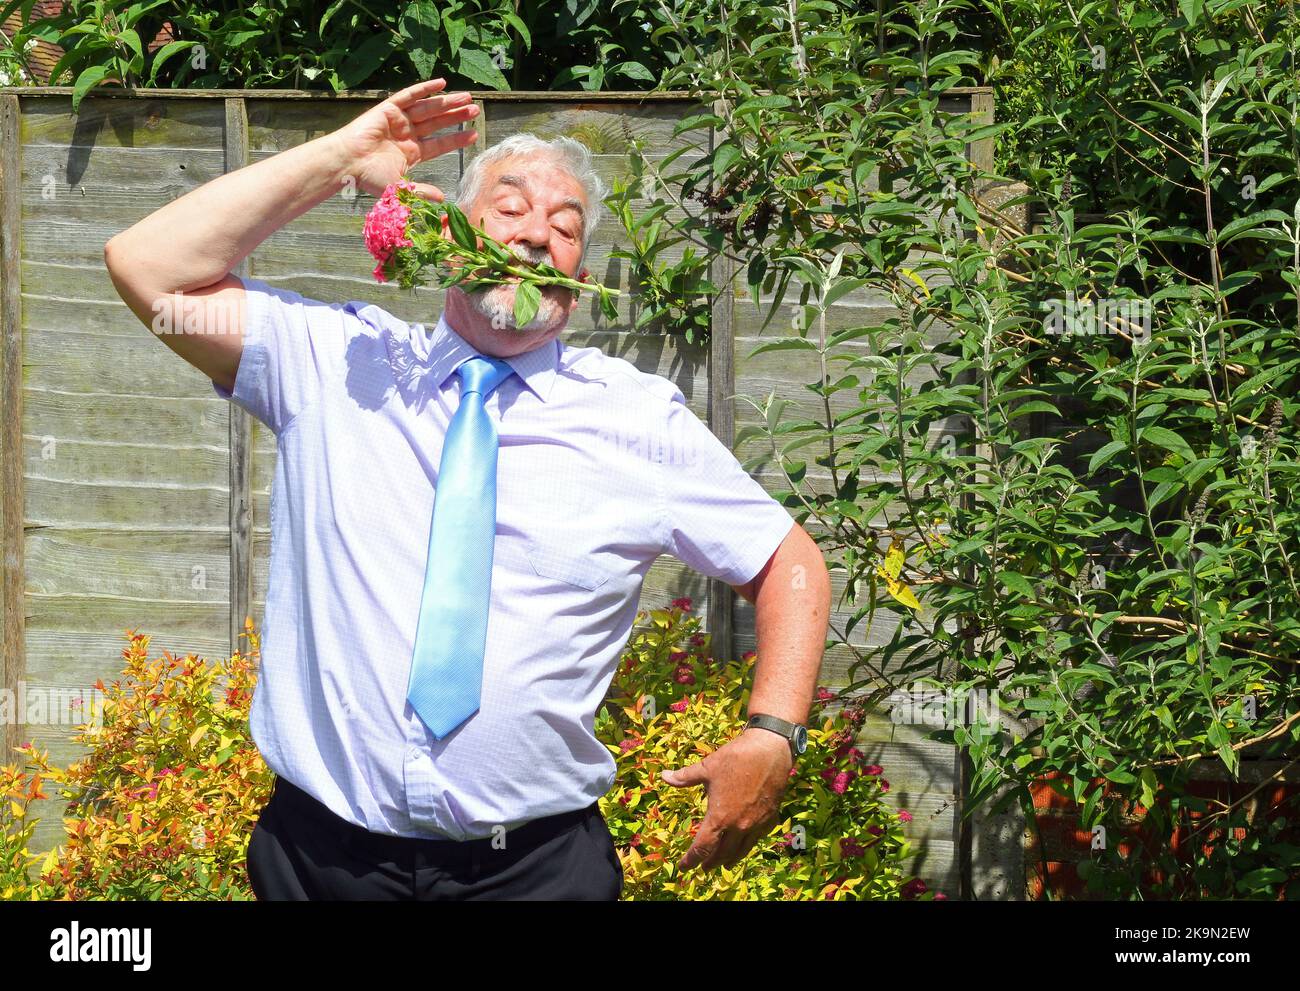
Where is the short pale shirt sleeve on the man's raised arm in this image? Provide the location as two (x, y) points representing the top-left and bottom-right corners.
(212, 276), (367, 437)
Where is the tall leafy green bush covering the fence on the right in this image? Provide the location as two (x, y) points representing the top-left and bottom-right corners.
(615, 0), (1300, 899)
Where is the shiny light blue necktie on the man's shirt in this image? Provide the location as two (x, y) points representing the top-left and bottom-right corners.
(407, 355), (512, 740)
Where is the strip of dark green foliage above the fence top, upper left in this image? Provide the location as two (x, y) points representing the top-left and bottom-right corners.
(0, 0), (707, 109)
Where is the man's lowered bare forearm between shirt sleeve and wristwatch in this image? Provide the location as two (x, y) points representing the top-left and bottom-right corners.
(749, 527), (831, 723)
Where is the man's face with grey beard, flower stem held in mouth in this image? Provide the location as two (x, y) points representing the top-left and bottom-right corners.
(443, 156), (588, 342)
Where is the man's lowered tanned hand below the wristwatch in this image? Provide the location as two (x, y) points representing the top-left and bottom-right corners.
(660, 728), (794, 870)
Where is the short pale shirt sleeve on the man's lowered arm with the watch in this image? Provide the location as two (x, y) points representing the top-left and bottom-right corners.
(658, 390), (794, 585)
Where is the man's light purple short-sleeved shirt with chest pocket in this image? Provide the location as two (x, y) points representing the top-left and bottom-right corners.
(213, 278), (794, 840)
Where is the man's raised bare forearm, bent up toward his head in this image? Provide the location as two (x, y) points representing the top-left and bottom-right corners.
(109, 134), (348, 293)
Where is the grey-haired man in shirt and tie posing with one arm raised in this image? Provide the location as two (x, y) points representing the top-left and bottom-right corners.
(104, 79), (831, 900)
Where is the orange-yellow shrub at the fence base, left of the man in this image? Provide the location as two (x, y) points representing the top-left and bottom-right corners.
(9, 623), (272, 900)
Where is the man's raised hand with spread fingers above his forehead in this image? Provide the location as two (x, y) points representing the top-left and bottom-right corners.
(330, 79), (478, 203)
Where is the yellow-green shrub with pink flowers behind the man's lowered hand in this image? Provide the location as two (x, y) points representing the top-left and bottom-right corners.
(595, 600), (943, 900)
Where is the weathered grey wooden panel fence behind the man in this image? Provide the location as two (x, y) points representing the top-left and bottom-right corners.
(0, 87), (1003, 897)
